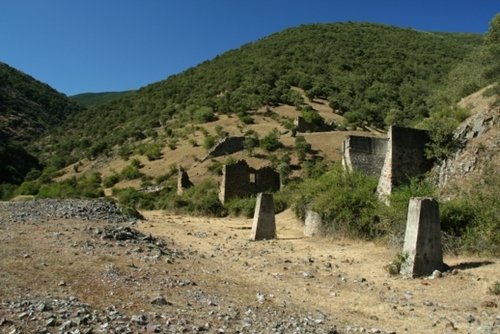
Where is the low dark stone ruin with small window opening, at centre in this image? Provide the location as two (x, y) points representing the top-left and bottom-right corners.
(219, 160), (281, 204)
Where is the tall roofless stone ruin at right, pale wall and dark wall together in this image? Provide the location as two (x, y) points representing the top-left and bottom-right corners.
(342, 126), (432, 199)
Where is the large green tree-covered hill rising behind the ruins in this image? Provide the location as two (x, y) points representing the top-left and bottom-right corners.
(44, 22), (482, 163)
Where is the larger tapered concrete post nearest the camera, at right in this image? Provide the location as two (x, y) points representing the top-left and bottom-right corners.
(401, 197), (445, 277)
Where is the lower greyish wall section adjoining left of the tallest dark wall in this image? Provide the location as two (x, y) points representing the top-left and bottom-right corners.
(342, 136), (388, 177)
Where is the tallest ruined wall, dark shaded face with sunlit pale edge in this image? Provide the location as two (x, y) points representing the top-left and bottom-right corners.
(377, 126), (432, 197)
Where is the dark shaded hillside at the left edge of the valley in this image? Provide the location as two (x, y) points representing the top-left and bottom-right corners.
(0, 62), (85, 184)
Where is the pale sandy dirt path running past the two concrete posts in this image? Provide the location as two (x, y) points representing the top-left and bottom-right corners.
(140, 211), (500, 333)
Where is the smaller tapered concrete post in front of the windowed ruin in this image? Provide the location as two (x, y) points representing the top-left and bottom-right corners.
(250, 193), (276, 240)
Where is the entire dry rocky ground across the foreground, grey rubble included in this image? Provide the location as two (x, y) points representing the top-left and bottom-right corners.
(0, 200), (500, 333)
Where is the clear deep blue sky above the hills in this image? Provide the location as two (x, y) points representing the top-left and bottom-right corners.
(0, 0), (500, 96)
